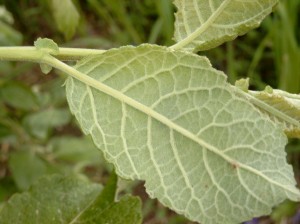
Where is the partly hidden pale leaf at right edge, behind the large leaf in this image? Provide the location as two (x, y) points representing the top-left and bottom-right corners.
(249, 87), (300, 138)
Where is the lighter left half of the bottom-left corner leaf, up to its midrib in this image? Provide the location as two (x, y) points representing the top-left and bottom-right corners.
(0, 175), (102, 224)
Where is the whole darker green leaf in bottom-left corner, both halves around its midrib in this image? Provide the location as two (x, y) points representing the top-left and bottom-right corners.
(0, 175), (141, 224)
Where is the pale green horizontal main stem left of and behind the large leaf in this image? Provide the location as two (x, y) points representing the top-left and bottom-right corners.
(0, 47), (105, 62)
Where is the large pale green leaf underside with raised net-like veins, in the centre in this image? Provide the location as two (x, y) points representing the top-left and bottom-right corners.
(66, 45), (300, 224)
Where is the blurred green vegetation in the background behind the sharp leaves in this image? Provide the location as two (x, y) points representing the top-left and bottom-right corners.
(0, 0), (300, 224)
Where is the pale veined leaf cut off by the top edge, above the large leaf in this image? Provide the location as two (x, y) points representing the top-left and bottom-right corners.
(174, 0), (278, 51)
